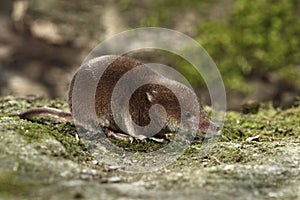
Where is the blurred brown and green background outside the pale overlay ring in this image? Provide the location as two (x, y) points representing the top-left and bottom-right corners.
(0, 0), (300, 109)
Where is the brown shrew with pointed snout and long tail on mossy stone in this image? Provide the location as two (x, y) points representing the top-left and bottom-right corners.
(14, 55), (219, 139)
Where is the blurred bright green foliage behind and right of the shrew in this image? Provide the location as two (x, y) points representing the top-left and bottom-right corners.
(197, 0), (300, 92)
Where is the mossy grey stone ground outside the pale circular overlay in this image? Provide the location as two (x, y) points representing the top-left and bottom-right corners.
(0, 96), (300, 199)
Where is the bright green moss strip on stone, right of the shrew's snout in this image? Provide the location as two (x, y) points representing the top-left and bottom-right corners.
(221, 106), (300, 141)
